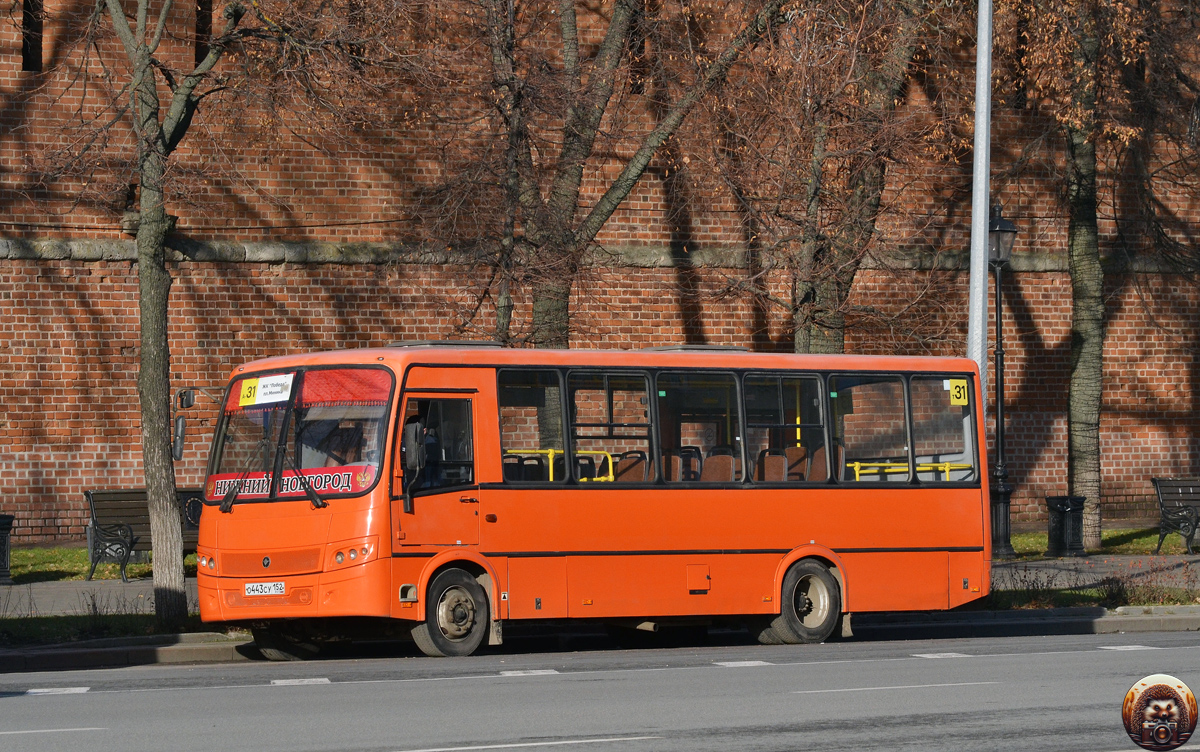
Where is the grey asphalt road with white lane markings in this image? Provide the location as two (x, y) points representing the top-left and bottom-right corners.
(0, 633), (1200, 752)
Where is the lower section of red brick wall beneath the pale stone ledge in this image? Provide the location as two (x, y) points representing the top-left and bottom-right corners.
(0, 244), (1200, 543)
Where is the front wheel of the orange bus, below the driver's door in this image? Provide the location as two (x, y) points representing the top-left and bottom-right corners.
(413, 570), (491, 657)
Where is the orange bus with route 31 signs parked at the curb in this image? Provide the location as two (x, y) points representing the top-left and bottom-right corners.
(198, 343), (991, 660)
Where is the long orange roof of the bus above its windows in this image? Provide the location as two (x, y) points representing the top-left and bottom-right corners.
(223, 342), (978, 386)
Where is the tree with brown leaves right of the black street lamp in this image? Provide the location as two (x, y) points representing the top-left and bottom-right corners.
(998, 0), (1151, 549)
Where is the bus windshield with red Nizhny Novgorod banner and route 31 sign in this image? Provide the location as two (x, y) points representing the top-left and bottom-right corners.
(205, 368), (392, 501)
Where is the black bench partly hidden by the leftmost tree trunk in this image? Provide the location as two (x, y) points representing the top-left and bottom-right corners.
(84, 488), (204, 582)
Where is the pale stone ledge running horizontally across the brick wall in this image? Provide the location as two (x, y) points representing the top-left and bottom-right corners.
(0, 236), (1172, 273)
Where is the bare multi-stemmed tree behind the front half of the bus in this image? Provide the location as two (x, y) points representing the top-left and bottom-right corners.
(410, 0), (788, 347)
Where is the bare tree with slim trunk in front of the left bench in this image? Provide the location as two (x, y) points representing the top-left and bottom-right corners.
(21, 0), (420, 625)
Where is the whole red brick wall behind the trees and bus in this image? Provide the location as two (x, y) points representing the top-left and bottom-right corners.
(0, 0), (1200, 542)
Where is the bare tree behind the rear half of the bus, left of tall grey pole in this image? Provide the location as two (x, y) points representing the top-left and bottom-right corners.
(710, 1), (950, 353)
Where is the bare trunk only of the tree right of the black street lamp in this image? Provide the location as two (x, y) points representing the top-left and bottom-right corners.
(1067, 119), (1105, 549)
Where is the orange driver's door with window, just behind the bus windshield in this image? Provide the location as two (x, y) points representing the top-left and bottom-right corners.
(391, 368), (494, 549)
